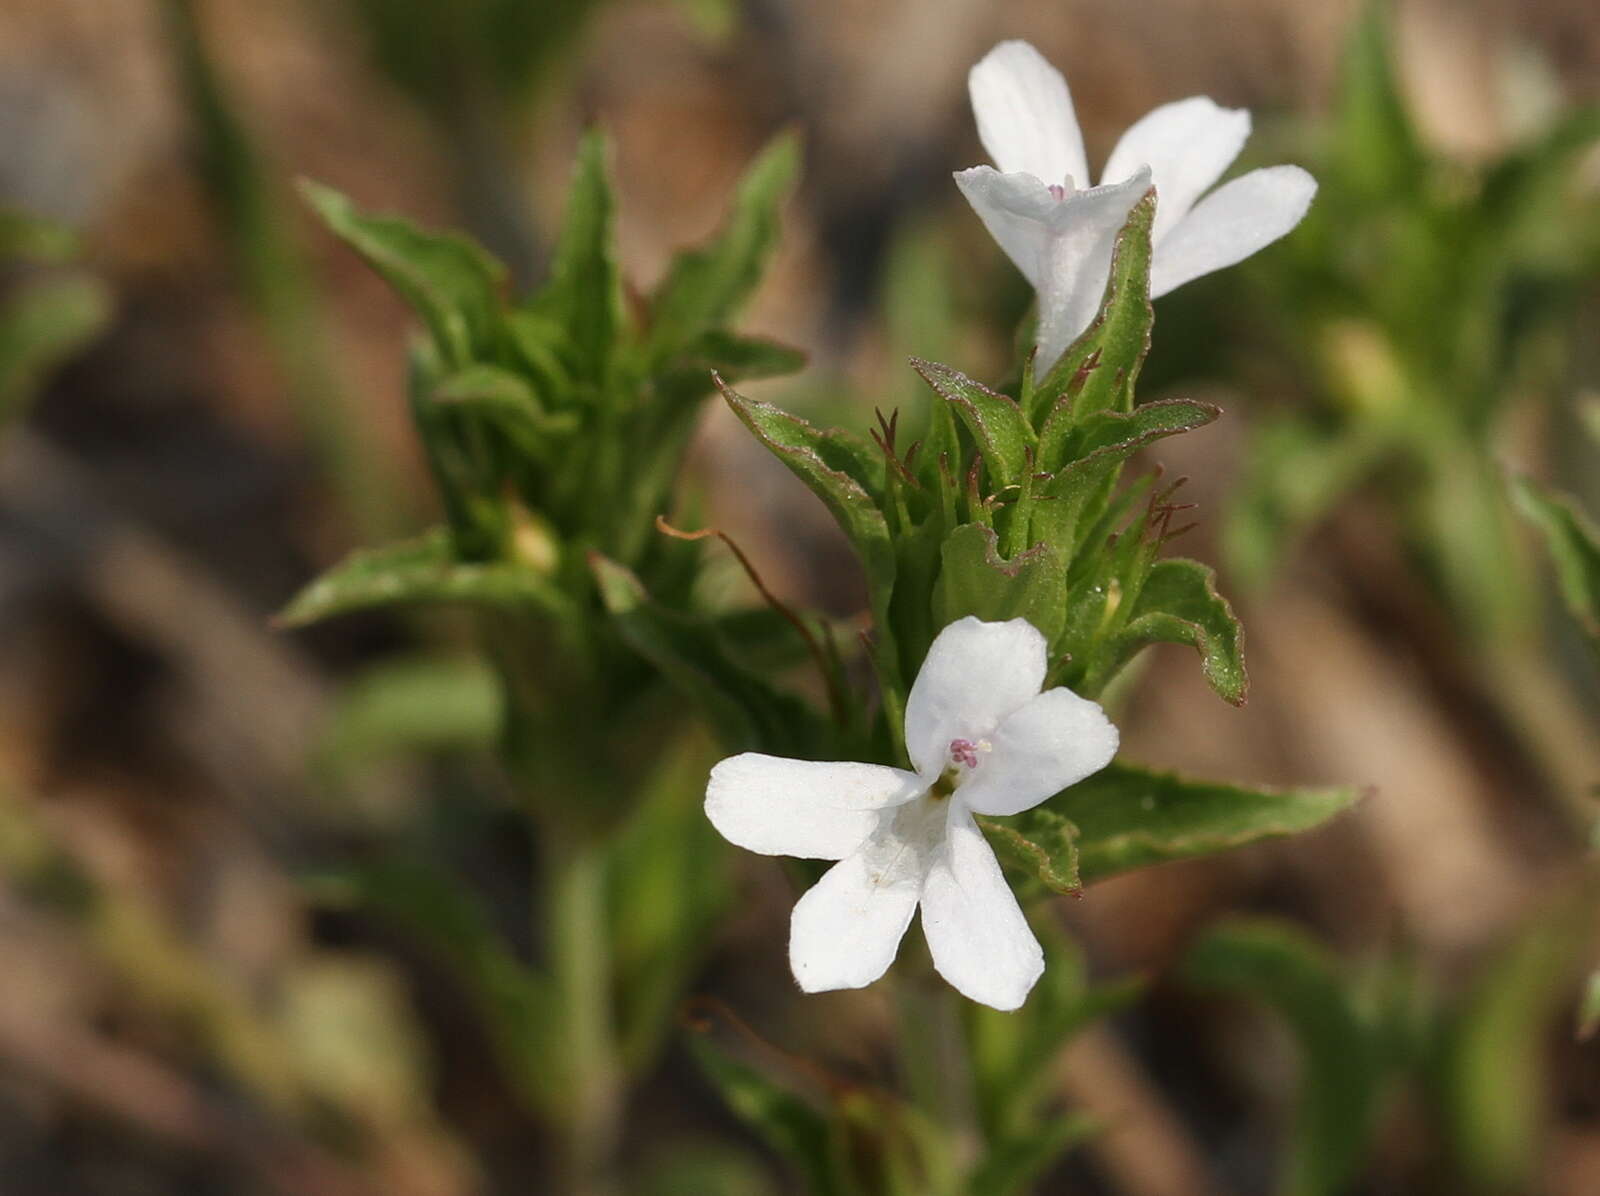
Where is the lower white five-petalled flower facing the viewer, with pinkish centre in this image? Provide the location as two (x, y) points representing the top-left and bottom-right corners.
(706, 617), (1117, 1009)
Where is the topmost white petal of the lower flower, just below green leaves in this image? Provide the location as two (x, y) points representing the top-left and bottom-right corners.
(906, 616), (1048, 782)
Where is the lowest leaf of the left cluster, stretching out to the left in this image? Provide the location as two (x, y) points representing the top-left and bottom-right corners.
(275, 529), (573, 627)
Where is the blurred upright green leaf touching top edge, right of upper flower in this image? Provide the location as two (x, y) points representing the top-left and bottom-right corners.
(1334, 0), (1426, 198)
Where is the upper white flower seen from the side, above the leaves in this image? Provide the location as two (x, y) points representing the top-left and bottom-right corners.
(955, 42), (1317, 373)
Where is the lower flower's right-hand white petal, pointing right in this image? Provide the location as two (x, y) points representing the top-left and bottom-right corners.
(955, 689), (1118, 815)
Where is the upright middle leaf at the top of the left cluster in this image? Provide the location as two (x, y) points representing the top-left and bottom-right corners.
(531, 130), (624, 384)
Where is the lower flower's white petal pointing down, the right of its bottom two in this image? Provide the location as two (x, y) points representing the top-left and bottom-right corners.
(922, 801), (1045, 1009)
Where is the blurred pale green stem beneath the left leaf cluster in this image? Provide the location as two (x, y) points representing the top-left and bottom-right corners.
(546, 825), (622, 1196)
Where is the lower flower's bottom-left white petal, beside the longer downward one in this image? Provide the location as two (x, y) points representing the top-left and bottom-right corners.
(789, 854), (918, 993)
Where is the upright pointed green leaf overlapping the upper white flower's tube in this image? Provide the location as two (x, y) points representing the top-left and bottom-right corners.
(1024, 187), (1155, 424)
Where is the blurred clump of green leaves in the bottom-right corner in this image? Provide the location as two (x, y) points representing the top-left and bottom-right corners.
(1184, 878), (1595, 1196)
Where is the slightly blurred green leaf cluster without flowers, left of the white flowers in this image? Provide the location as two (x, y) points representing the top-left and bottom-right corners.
(282, 133), (802, 812)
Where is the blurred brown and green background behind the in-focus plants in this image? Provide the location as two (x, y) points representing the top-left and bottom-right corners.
(0, 0), (1600, 1196)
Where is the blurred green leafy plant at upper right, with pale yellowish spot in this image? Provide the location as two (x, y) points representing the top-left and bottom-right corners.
(1227, 3), (1600, 638)
